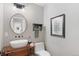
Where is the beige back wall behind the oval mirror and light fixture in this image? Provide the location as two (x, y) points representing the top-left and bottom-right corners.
(4, 3), (43, 46)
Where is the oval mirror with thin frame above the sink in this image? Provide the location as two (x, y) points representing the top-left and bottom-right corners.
(10, 14), (27, 34)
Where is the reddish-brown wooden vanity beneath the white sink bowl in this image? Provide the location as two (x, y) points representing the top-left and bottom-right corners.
(3, 44), (34, 56)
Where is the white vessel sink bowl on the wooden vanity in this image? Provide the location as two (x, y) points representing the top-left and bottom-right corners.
(10, 39), (28, 48)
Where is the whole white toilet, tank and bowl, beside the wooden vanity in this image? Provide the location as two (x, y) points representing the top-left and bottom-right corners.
(35, 42), (50, 56)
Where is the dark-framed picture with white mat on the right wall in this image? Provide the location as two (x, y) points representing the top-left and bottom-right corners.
(50, 14), (65, 38)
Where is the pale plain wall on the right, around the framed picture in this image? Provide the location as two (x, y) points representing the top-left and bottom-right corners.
(44, 3), (79, 56)
